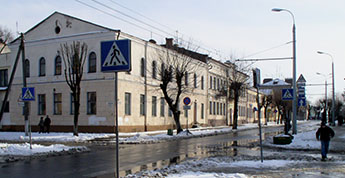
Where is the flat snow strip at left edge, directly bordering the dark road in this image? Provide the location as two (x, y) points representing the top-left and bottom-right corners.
(0, 143), (87, 156)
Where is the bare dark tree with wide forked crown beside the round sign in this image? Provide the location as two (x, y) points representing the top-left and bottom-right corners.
(157, 41), (206, 133)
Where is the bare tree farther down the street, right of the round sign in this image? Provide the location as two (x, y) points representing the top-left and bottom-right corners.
(225, 61), (249, 129)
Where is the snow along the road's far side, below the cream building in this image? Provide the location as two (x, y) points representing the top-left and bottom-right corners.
(0, 120), (312, 159)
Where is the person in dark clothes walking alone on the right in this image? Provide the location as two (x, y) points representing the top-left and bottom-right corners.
(316, 122), (335, 161)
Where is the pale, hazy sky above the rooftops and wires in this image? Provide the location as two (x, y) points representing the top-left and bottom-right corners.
(0, 0), (345, 101)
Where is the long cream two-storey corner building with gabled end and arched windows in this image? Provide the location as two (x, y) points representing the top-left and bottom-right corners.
(0, 12), (256, 132)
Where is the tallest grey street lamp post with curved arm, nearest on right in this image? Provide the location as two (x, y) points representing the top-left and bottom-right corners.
(272, 8), (297, 134)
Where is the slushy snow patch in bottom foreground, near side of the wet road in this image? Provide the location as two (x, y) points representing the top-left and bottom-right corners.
(126, 157), (302, 178)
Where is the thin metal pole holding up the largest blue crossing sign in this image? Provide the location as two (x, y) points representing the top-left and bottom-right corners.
(114, 72), (120, 178)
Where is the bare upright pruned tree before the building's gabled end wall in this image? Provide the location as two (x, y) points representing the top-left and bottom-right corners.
(60, 41), (87, 136)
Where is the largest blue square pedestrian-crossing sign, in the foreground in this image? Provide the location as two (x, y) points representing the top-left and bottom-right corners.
(101, 39), (131, 72)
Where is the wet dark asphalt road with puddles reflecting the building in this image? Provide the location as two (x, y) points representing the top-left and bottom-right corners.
(0, 127), (282, 178)
